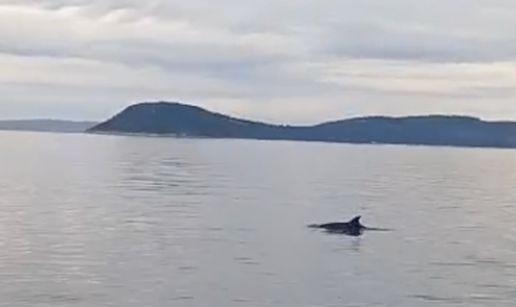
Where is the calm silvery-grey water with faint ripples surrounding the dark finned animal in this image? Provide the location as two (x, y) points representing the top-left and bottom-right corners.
(0, 132), (516, 307)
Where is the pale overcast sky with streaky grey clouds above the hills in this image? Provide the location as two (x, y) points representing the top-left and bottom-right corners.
(0, 0), (516, 124)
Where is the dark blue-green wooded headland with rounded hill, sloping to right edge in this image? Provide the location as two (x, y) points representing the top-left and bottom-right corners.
(86, 102), (516, 148)
